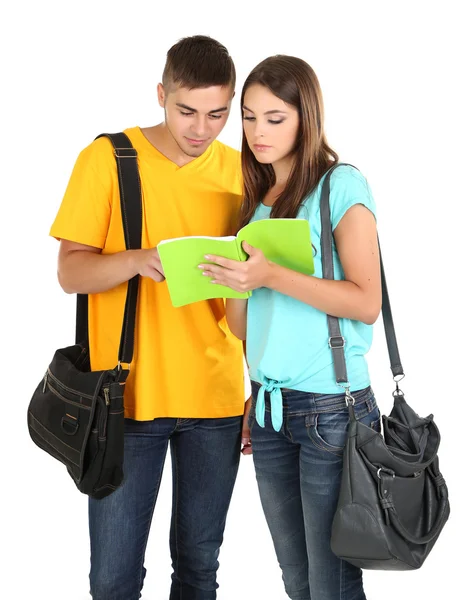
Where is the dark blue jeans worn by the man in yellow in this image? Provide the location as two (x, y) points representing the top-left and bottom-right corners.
(89, 416), (242, 600)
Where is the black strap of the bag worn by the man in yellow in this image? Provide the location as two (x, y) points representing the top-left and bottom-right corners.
(76, 133), (142, 364)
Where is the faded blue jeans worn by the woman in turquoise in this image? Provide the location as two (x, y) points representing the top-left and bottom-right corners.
(249, 382), (380, 600)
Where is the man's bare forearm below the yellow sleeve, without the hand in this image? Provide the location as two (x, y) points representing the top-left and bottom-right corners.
(58, 250), (139, 294)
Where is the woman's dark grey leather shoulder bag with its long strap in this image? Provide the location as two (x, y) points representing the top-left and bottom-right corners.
(320, 165), (450, 571)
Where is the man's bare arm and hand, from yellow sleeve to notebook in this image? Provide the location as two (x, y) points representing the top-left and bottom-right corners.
(58, 240), (165, 294)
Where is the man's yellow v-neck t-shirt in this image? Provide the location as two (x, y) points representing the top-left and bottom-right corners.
(50, 127), (244, 421)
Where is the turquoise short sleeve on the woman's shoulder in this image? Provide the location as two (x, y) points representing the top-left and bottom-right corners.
(329, 165), (376, 231)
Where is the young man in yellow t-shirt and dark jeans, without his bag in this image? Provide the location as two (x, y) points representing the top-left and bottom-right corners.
(50, 36), (248, 600)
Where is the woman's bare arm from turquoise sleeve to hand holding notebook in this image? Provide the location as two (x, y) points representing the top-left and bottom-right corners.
(202, 204), (381, 324)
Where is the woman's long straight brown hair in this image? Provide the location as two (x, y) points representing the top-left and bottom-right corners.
(239, 55), (339, 227)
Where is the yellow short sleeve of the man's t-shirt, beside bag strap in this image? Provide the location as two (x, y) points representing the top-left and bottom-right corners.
(50, 139), (116, 248)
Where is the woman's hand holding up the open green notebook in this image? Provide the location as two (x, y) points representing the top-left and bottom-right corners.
(199, 242), (273, 292)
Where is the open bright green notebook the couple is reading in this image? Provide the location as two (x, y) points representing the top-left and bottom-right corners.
(158, 219), (314, 307)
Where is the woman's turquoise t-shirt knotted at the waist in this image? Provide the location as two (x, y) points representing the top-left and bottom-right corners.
(247, 166), (375, 430)
